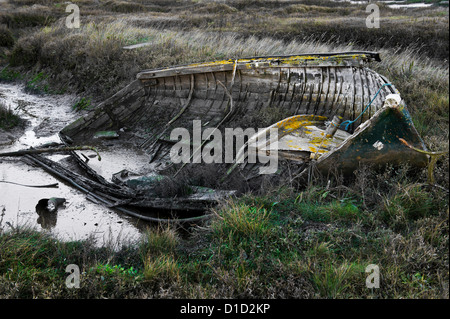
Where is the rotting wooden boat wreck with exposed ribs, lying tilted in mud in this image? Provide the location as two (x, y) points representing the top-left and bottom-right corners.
(51, 52), (427, 222)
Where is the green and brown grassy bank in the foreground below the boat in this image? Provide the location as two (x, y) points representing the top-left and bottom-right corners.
(0, 170), (449, 298)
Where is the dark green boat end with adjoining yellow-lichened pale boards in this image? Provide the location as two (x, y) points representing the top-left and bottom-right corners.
(229, 94), (428, 175)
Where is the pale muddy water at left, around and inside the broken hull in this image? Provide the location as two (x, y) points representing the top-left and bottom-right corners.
(0, 84), (146, 247)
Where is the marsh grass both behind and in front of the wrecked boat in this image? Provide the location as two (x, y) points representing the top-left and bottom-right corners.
(0, 0), (449, 298)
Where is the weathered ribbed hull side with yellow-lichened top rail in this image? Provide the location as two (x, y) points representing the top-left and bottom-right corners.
(62, 52), (397, 169)
